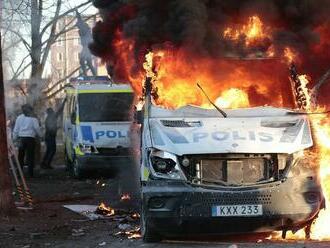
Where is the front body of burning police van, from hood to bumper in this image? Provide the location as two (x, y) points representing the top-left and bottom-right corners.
(141, 83), (325, 242)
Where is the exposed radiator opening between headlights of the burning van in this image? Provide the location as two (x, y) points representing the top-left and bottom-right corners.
(182, 154), (285, 186)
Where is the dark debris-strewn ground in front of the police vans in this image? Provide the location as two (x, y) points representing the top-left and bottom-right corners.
(0, 157), (330, 248)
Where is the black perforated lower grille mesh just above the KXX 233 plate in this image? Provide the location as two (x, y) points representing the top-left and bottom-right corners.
(180, 192), (272, 217)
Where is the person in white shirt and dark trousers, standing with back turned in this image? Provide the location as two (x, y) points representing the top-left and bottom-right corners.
(13, 104), (42, 177)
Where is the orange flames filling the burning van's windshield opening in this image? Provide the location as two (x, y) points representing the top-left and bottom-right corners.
(137, 51), (282, 108)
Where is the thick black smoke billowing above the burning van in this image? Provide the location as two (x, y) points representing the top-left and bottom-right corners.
(90, 0), (330, 104)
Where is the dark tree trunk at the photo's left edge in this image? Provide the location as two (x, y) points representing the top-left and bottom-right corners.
(0, 34), (15, 216)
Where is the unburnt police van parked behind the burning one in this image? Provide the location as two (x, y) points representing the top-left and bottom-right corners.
(63, 76), (134, 178)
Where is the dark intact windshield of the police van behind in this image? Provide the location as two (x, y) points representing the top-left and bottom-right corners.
(78, 93), (133, 122)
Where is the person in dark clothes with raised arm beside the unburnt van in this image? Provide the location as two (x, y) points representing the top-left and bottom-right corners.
(40, 100), (66, 169)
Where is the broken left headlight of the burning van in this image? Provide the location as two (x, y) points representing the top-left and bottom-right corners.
(150, 150), (186, 180)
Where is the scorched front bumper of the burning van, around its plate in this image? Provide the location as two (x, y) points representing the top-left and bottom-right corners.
(142, 178), (324, 236)
